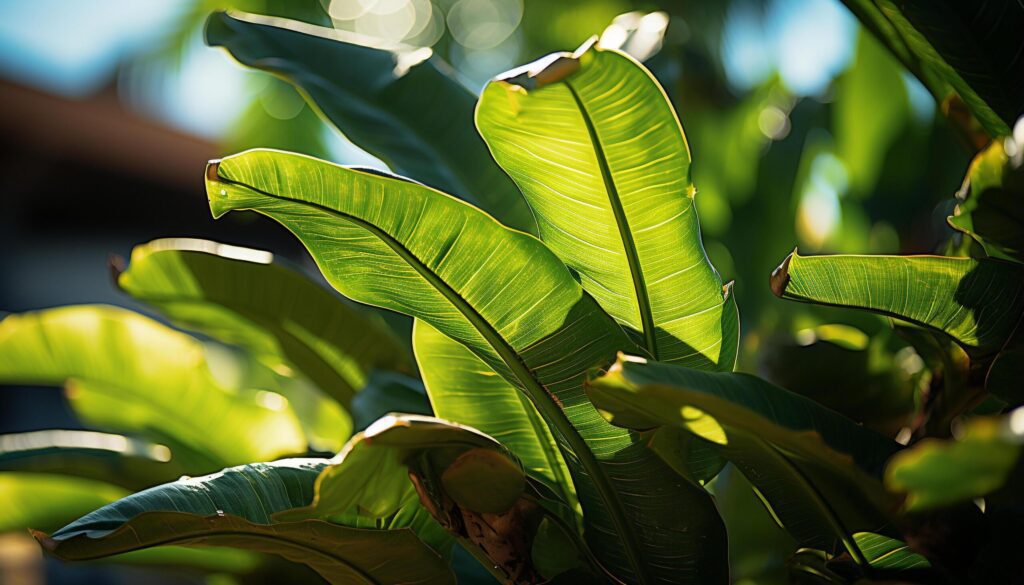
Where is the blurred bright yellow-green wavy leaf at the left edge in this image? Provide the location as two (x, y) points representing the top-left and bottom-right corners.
(0, 305), (317, 470)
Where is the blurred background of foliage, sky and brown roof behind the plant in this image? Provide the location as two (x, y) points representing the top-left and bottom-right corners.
(0, 0), (987, 582)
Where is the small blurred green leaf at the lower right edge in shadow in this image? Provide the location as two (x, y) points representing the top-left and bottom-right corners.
(886, 409), (1024, 511)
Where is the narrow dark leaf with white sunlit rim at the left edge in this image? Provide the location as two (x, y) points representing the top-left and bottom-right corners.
(0, 429), (185, 489)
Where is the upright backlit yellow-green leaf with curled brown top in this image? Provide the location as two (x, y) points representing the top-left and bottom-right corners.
(476, 46), (739, 370)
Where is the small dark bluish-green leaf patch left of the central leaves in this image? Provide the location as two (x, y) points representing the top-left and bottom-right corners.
(351, 370), (434, 430)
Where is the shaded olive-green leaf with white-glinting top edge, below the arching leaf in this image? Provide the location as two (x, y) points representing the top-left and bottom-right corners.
(117, 239), (411, 406)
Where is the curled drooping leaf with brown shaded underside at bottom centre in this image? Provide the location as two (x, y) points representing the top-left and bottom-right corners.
(289, 415), (580, 583)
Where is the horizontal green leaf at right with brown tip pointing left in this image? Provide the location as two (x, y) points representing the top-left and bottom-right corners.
(771, 252), (1024, 356)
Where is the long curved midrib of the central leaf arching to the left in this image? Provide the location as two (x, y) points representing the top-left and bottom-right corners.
(217, 173), (649, 584)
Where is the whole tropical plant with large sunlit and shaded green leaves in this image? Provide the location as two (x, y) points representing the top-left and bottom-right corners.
(0, 3), (1024, 584)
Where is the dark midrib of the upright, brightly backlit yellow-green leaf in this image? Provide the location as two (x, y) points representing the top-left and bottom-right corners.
(562, 79), (657, 360)
